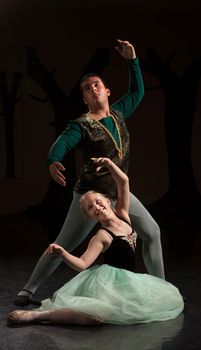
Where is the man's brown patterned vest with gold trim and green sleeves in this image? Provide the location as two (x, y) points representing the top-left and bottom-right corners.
(48, 58), (144, 198)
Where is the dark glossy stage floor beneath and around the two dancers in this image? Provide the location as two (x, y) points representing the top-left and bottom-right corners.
(0, 216), (201, 350)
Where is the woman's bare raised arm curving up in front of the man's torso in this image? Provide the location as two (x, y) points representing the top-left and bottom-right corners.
(92, 158), (130, 215)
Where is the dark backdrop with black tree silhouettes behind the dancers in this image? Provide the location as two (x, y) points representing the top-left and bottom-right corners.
(0, 0), (201, 256)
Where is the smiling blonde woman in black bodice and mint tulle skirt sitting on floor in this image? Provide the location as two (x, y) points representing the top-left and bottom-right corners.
(8, 158), (184, 325)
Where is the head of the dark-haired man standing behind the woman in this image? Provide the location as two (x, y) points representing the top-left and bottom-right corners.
(81, 76), (110, 109)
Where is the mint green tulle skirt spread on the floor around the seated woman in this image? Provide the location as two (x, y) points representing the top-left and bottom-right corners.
(40, 264), (184, 325)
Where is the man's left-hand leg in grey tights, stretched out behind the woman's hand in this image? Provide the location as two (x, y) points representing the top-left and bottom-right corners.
(16, 193), (96, 305)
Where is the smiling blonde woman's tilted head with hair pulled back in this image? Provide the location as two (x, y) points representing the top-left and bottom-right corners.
(82, 193), (111, 221)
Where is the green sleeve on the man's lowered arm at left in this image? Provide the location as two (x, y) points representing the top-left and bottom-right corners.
(47, 121), (82, 165)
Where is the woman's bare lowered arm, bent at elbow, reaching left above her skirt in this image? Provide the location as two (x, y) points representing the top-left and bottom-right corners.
(44, 230), (111, 272)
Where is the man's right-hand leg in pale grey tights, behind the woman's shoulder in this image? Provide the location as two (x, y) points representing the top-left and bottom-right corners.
(129, 193), (165, 279)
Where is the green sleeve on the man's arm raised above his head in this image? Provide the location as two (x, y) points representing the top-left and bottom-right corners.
(111, 58), (144, 119)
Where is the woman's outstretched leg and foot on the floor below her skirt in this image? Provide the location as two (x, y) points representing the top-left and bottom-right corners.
(7, 309), (102, 326)
